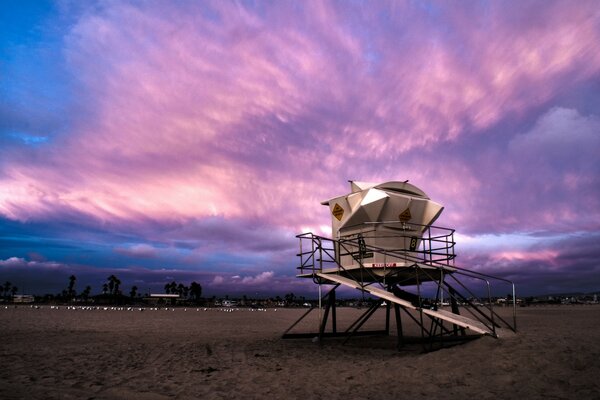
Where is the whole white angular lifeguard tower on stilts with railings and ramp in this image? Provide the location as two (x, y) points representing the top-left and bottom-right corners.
(283, 181), (516, 349)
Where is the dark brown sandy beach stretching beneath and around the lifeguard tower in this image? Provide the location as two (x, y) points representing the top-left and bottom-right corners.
(0, 305), (600, 400)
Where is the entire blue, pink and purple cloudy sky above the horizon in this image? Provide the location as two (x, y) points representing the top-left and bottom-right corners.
(0, 0), (600, 297)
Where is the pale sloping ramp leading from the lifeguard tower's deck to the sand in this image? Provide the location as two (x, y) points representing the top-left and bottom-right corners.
(316, 272), (494, 336)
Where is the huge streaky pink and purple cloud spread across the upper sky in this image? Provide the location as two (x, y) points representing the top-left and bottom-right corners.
(0, 2), (600, 241)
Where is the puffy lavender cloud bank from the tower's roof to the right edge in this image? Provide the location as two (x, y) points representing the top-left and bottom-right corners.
(423, 107), (600, 234)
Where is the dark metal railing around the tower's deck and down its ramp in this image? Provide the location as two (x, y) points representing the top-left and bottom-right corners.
(296, 221), (517, 335)
